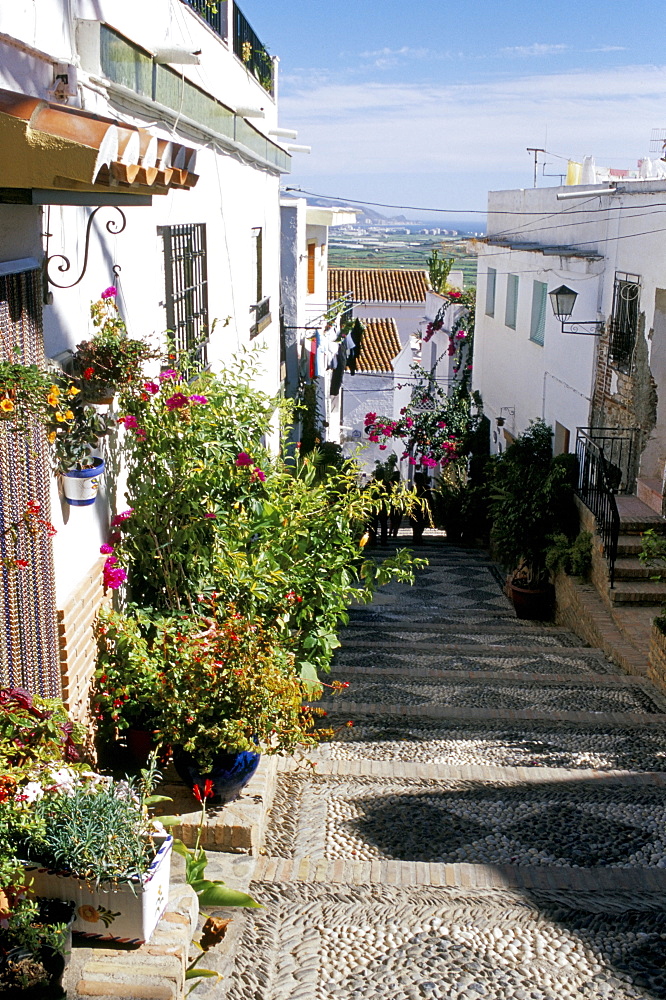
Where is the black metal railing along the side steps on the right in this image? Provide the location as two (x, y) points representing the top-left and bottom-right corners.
(576, 427), (620, 587)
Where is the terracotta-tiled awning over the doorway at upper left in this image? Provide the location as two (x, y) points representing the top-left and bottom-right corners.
(0, 90), (198, 195)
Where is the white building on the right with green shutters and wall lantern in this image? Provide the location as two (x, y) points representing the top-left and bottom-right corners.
(474, 180), (666, 500)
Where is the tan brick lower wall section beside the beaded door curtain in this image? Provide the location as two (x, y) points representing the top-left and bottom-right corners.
(58, 559), (110, 723)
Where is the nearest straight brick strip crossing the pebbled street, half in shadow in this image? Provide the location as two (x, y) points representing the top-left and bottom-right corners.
(254, 857), (666, 896)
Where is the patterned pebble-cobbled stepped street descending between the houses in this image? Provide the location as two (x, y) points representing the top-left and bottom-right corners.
(210, 539), (666, 1000)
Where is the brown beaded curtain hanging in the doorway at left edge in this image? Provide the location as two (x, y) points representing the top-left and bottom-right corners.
(0, 270), (60, 697)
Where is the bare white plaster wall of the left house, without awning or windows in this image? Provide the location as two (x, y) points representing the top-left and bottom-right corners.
(0, 0), (289, 607)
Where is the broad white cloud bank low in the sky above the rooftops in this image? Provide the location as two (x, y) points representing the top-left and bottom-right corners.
(280, 66), (666, 189)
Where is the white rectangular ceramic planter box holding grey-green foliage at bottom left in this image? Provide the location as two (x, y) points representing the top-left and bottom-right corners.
(26, 837), (173, 944)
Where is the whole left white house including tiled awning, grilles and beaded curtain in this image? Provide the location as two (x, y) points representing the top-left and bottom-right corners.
(0, 0), (294, 720)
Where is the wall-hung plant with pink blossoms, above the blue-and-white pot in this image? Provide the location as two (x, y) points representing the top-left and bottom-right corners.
(72, 285), (157, 403)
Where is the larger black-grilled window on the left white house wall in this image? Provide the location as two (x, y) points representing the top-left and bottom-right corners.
(159, 223), (208, 368)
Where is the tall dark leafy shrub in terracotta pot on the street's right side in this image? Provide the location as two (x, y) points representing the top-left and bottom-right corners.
(490, 420), (576, 618)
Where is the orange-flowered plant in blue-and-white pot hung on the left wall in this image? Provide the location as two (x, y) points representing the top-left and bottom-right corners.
(47, 385), (116, 507)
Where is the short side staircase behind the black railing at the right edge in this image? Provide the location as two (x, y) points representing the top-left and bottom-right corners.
(608, 496), (666, 606)
